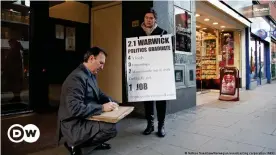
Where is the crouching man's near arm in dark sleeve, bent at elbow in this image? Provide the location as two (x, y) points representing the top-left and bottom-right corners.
(65, 76), (102, 118)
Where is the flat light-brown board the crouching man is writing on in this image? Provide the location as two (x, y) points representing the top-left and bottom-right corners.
(88, 106), (134, 123)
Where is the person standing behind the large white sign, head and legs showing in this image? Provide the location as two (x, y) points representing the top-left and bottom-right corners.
(135, 9), (167, 137)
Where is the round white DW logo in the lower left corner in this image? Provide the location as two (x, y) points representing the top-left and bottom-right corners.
(7, 124), (40, 143)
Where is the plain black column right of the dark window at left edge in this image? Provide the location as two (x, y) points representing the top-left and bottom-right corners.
(29, 1), (49, 112)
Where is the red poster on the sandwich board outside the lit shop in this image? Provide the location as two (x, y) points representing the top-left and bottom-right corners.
(220, 68), (237, 95)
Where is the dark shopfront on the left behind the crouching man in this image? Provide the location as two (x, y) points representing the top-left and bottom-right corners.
(1, 0), (92, 117)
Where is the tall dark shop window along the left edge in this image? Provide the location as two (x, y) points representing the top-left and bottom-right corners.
(1, 1), (29, 114)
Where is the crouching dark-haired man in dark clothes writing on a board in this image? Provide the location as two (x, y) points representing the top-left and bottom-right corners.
(58, 47), (118, 155)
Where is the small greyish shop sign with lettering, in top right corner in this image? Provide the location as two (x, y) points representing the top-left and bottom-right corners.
(241, 4), (270, 18)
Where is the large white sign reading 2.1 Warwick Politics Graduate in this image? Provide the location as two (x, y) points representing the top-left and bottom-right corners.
(126, 34), (176, 102)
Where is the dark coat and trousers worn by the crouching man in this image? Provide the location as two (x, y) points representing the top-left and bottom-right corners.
(57, 64), (115, 146)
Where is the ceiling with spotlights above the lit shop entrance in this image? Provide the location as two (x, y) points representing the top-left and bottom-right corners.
(196, 1), (245, 31)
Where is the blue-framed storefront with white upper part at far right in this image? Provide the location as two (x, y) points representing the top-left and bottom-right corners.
(249, 17), (271, 89)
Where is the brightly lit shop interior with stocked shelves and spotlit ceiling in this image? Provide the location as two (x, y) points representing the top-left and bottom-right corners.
(196, 2), (244, 92)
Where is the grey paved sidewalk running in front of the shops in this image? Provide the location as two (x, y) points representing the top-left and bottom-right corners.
(30, 83), (276, 155)
